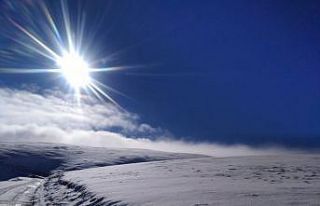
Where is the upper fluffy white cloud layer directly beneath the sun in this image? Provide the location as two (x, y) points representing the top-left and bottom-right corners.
(0, 89), (160, 134)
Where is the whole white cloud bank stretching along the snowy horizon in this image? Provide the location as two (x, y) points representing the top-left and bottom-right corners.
(0, 88), (290, 156)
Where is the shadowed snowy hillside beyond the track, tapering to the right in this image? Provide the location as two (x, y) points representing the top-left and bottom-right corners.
(0, 143), (205, 181)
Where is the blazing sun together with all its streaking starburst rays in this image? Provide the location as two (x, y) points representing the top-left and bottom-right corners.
(0, 0), (132, 108)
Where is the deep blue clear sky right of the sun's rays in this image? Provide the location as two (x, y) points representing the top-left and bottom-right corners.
(1, 0), (320, 146)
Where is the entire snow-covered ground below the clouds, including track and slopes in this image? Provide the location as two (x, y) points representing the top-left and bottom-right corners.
(0, 143), (320, 206)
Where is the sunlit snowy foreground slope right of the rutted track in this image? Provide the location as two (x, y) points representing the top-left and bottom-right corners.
(55, 154), (320, 206)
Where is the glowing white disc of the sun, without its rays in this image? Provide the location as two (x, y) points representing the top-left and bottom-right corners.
(56, 52), (91, 90)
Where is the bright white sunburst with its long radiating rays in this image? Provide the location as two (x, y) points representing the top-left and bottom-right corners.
(0, 0), (129, 107)
